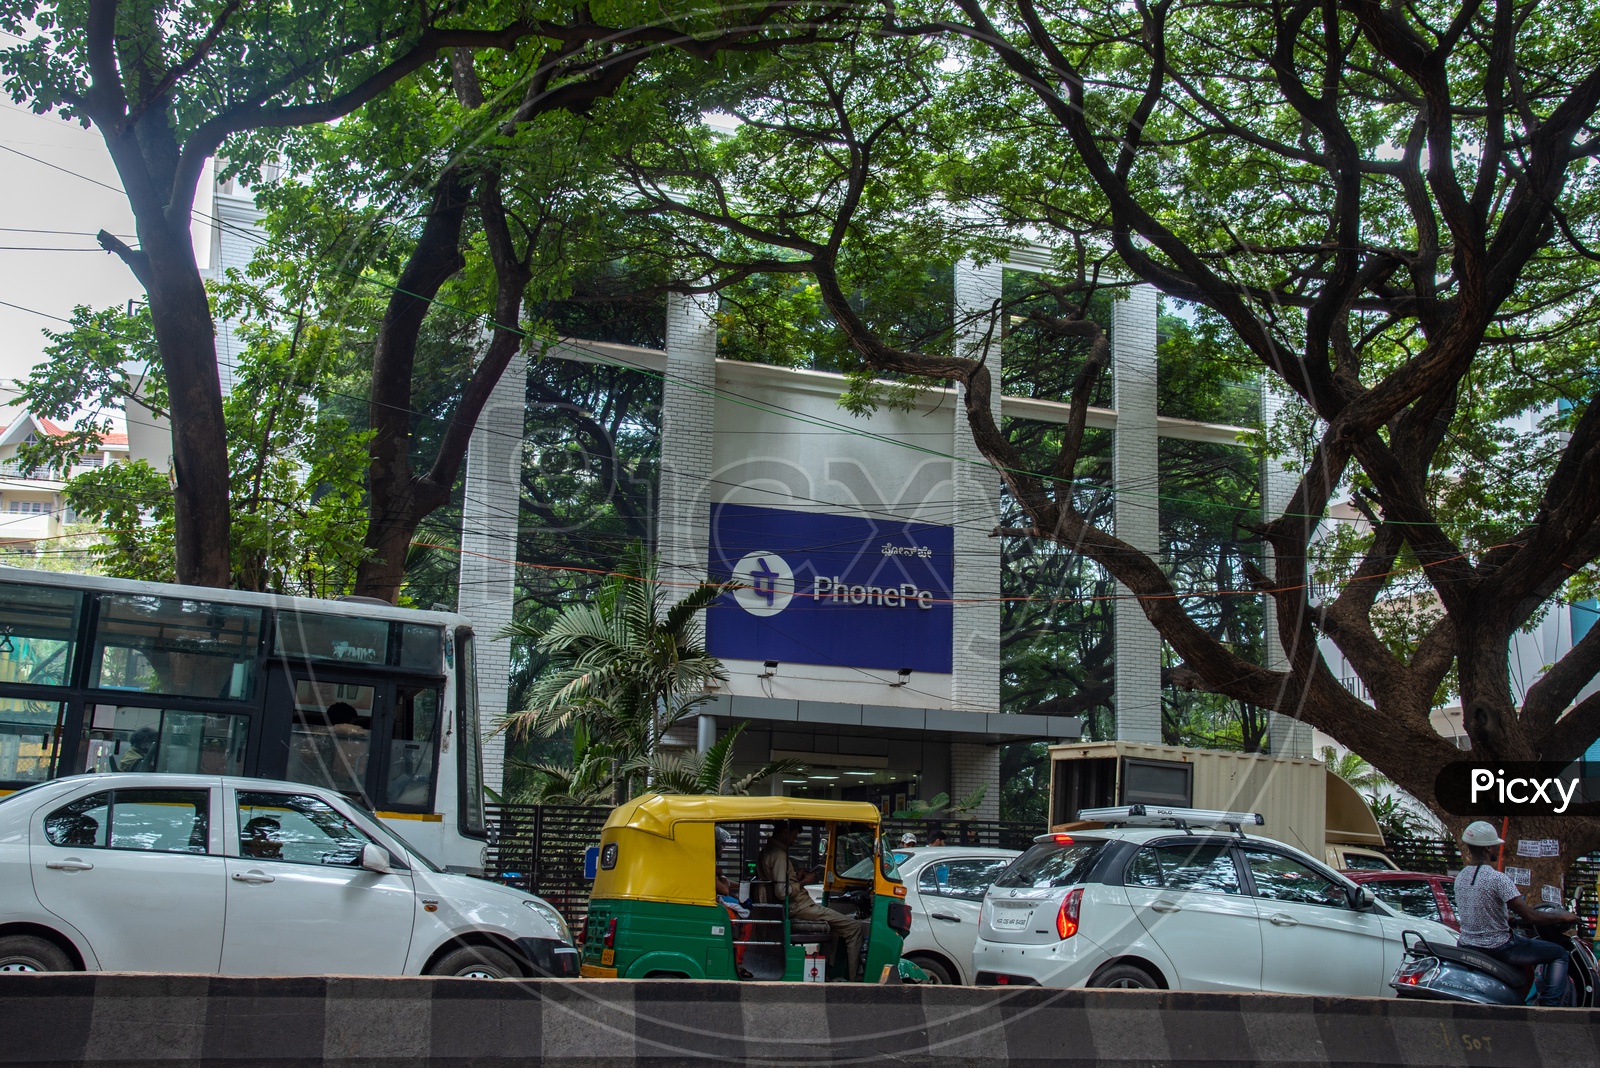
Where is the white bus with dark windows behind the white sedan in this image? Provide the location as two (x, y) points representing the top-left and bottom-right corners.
(0, 566), (488, 875)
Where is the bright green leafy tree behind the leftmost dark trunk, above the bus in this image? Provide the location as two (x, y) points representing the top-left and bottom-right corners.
(21, 295), (368, 596)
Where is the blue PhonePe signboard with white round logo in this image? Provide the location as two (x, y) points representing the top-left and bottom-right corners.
(706, 504), (955, 675)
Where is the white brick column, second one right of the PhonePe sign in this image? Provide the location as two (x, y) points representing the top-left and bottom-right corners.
(1110, 285), (1162, 742)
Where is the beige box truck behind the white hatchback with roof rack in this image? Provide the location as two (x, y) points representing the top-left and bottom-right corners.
(1050, 742), (1395, 871)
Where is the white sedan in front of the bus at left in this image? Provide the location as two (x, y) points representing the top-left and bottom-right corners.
(0, 772), (578, 978)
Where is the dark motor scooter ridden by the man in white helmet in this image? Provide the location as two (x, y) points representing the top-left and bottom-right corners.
(1389, 905), (1600, 1007)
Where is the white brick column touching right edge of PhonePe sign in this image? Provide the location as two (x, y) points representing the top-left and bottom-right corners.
(950, 261), (1002, 716)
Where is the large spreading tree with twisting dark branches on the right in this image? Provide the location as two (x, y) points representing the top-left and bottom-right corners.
(617, 8), (1600, 884)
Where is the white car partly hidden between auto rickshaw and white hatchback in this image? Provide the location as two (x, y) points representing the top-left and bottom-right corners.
(894, 846), (1019, 983)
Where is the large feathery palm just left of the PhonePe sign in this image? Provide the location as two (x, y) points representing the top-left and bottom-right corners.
(499, 545), (728, 799)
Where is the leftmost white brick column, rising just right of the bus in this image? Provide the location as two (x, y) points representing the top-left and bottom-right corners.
(456, 352), (528, 791)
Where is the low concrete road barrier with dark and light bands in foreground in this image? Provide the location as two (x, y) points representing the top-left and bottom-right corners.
(0, 974), (1600, 1068)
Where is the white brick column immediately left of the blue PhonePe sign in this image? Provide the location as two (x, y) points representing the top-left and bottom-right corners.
(656, 294), (717, 585)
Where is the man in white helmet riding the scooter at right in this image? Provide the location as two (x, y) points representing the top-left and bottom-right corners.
(1456, 820), (1578, 1006)
